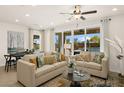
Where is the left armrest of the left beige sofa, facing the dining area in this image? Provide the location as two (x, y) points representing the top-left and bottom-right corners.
(17, 60), (35, 86)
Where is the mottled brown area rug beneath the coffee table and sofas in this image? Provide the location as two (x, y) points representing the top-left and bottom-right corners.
(0, 75), (124, 87)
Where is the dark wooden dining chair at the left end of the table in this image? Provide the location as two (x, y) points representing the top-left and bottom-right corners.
(4, 55), (16, 72)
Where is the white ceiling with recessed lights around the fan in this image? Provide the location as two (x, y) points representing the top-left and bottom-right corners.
(0, 5), (124, 29)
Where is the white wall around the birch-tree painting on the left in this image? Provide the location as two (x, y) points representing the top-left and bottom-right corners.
(0, 23), (29, 66)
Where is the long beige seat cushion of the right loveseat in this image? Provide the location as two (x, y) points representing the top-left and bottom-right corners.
(76, 61), (102, 70)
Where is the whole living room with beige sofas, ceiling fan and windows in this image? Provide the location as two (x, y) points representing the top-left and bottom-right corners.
(0, 0), (124, 92)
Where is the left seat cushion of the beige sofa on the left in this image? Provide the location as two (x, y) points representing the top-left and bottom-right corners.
(35, 65), (55, 78)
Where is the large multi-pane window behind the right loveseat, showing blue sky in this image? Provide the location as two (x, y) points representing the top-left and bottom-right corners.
(55, 27), (100, 54)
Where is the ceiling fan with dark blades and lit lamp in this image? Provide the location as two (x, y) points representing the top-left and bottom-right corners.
(60, 5), (97, 20)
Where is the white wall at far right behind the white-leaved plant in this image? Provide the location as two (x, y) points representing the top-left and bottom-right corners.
(109, 15), (124, 72)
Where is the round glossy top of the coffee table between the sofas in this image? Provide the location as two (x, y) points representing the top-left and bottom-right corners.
(63, 70), (90, 82)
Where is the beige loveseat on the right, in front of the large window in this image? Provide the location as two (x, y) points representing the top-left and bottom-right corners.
(76, 52), (109, 79)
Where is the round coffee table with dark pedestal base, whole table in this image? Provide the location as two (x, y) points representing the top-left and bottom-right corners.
(63, 71), (90, 87)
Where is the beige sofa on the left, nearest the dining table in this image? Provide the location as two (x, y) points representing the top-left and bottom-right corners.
(17, 55), (67, 86)
